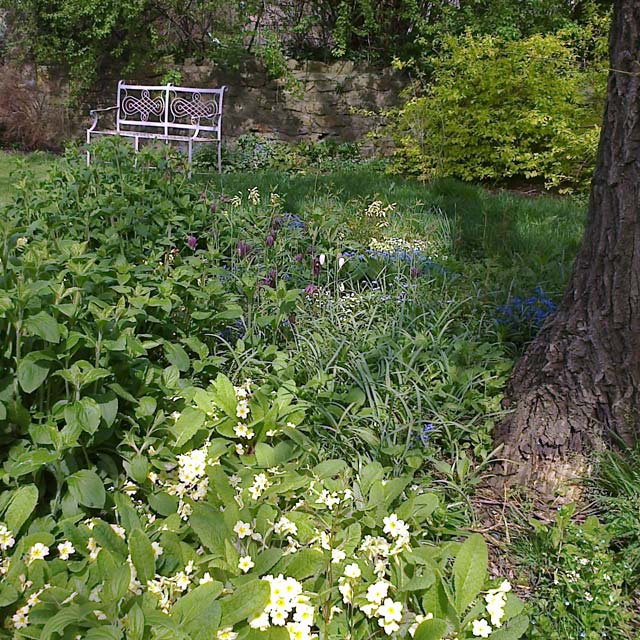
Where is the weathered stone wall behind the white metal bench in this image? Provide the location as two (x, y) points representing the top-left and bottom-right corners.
(0, 61), (407, 146)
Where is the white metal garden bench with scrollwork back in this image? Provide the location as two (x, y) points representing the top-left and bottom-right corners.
(87, 80), (226, 172)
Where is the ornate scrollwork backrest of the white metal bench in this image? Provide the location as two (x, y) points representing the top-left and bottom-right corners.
(116, 80), (226, 140)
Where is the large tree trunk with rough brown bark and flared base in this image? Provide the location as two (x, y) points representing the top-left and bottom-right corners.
(497, 0), (640, 497)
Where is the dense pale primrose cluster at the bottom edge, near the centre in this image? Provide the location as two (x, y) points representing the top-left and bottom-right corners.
(249, 574), (317, 640)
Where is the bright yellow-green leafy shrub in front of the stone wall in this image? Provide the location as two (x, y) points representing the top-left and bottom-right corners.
(391, 33), (605, 189)
